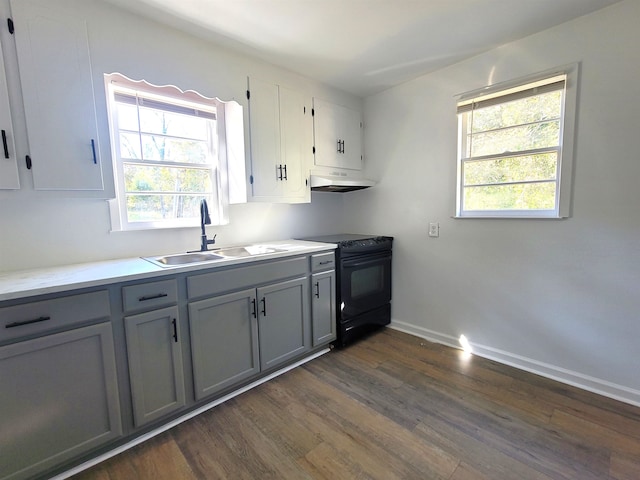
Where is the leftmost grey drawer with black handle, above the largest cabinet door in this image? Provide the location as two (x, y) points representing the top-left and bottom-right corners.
(0, 290), (111, 342)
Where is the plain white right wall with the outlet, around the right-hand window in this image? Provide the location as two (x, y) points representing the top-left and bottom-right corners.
(352, 0), (640, 404)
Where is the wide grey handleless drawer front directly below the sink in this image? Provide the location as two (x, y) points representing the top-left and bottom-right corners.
(187, 257), (307, 299)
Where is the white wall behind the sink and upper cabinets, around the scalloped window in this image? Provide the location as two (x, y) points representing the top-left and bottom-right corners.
(0, 0), (350, 272)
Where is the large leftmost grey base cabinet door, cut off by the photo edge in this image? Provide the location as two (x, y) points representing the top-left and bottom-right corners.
(0, 323), (122, 480)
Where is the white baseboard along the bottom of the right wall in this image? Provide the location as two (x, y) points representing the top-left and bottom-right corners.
(389, 320), (640, 407)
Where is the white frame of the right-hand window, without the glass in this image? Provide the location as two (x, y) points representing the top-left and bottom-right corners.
(454, 63), (579, 219)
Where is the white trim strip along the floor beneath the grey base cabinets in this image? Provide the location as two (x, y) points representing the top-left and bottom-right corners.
(50, 348), (331, 480)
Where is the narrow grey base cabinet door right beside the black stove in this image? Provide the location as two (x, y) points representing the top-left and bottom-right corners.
(311, 270), (336, 347)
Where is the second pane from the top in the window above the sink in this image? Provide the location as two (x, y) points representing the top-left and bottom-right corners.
(142, 135), (212, 165)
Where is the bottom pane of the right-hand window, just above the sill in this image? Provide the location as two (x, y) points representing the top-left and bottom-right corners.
(464, 182), (556, 210)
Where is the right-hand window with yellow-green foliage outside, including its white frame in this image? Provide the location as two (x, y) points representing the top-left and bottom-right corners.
(456, 66), (577, 218)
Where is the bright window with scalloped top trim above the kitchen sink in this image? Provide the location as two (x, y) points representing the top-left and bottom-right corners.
(105, 74), (246, 230)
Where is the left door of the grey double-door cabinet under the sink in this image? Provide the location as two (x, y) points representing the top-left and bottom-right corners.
(189, 289), (260, 400)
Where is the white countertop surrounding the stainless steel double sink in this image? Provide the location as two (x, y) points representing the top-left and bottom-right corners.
(0, 240), (336, 302)
